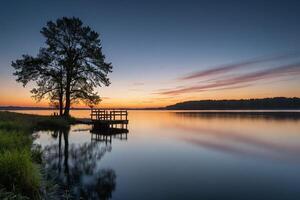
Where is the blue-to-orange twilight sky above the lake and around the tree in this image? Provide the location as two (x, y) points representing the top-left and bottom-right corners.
(0, 0), (300, 108)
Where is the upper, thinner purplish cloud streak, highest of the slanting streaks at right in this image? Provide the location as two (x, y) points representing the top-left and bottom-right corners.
(178, 52), (299, 80)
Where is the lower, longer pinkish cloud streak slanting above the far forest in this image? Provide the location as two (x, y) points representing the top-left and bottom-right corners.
(158, 63), (300, 95)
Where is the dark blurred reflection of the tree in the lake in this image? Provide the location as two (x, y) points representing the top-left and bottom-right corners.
(44, 129), (116, 199)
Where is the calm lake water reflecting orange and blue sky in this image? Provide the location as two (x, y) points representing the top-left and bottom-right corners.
(21, 111), (300, 200)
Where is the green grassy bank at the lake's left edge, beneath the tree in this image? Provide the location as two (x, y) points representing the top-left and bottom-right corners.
(0, 112), (74, 199)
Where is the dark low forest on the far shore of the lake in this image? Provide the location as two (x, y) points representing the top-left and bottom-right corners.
(165, 97), (300, 110)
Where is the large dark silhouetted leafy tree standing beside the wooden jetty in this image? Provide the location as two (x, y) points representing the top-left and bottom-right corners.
(12, 17), (112, 116)
